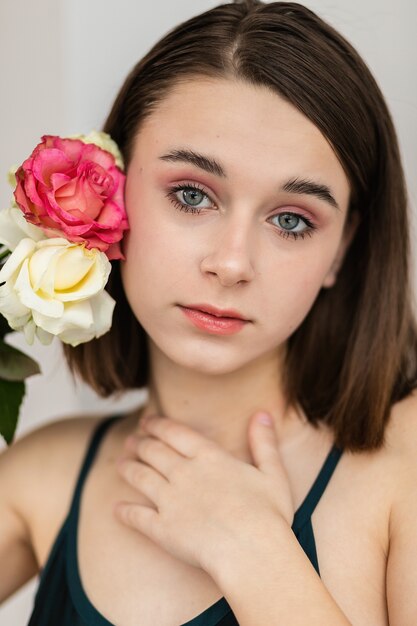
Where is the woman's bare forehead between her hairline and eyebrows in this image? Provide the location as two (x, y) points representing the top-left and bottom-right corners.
(133, 77), (349, 199)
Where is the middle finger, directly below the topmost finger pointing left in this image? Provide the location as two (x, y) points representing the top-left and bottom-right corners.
(125, 435), (185, 479)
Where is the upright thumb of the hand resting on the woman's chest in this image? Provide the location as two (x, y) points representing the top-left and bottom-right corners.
(249, 411), (284, 475)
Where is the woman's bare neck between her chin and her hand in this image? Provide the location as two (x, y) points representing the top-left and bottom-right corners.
(136, 341), (304, 462)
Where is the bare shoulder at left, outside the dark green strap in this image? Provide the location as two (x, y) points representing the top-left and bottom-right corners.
(0, 416), (112, 557)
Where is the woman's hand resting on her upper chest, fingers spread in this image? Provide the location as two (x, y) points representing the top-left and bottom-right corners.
(115, 413), (294, 572)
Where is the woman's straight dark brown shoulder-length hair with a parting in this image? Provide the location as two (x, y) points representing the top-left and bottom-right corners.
(64, 0), (417, 450)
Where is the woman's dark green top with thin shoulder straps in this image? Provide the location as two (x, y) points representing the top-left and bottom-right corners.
(28, 417), (342, 626)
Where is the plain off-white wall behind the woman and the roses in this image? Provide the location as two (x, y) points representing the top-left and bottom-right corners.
(0, 0), (417, 626)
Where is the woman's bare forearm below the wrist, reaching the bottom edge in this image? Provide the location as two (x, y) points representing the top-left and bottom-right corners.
(206, 520), (350, 626)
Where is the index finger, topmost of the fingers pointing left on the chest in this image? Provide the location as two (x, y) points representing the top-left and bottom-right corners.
(142, 415), (214, 458)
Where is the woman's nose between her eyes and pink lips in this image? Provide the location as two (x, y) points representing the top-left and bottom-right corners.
(200, 212), (255, 287)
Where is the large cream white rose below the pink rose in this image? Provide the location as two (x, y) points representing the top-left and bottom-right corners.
(0, 237), (115, 346)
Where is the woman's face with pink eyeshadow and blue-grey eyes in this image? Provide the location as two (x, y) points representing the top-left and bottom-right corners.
(122, 78), (349, 374)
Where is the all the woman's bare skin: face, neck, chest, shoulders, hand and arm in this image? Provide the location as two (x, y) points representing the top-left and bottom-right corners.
(0, 80), (417, 626)
